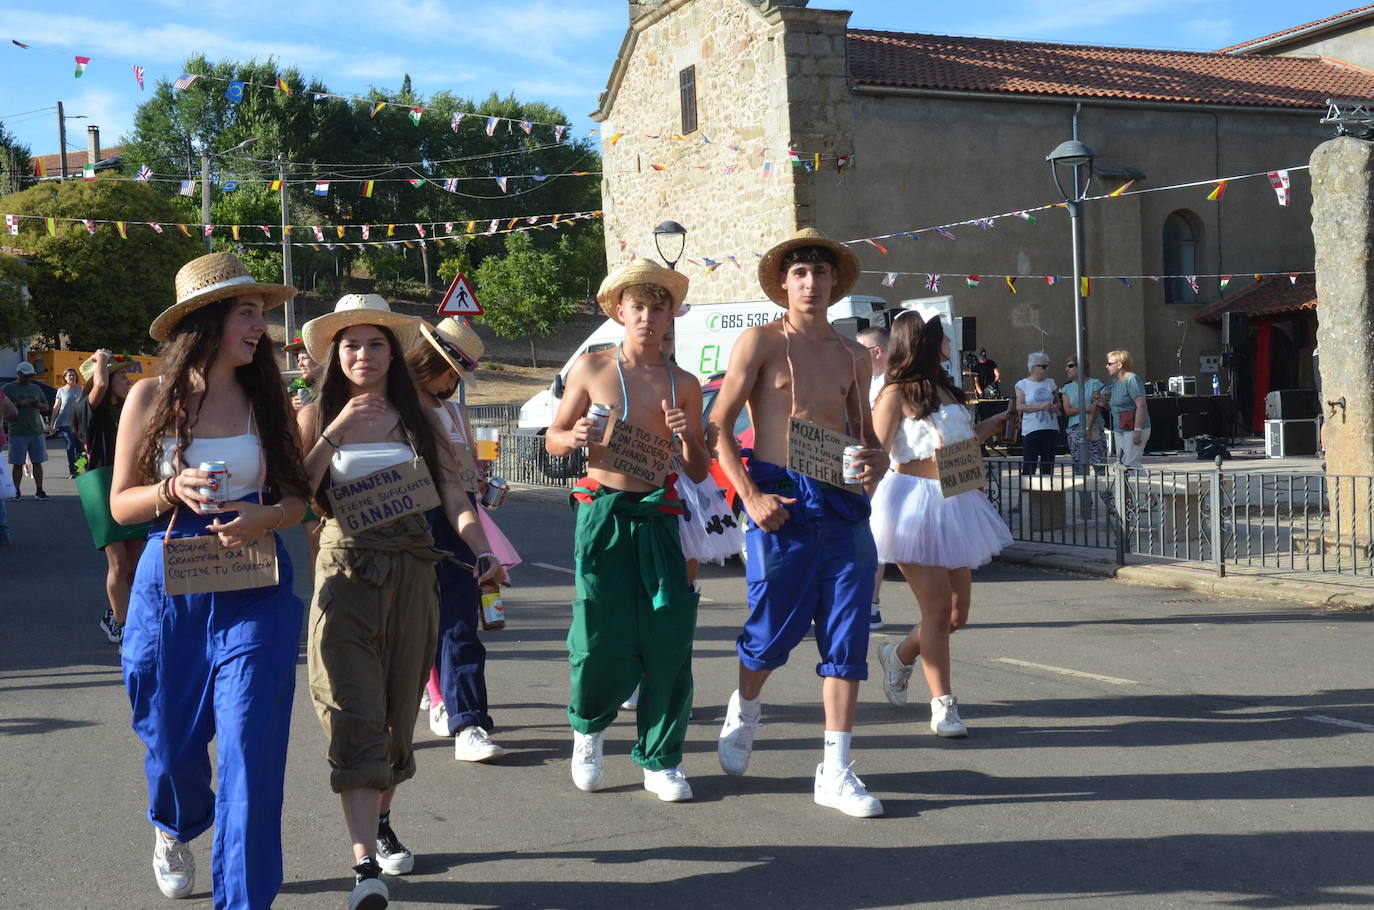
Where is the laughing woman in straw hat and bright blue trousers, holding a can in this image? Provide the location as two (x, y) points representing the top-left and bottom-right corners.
(111, 253), (306, 907)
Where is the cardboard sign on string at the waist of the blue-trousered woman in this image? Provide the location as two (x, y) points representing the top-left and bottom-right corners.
(162, 411), (280, 595)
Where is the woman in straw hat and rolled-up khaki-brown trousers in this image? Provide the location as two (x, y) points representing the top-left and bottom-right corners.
(298, 294), (506, 910)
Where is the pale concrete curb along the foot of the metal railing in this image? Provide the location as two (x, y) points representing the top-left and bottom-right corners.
(998, 546), (1374, 612)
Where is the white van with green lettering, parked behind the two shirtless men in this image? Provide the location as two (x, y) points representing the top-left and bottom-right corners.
(517, 294), (888, 433)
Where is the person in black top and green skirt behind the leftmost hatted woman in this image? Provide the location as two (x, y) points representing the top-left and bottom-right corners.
(71, 351), (148, 645)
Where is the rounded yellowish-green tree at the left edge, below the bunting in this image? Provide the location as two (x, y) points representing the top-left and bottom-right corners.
(5, 179), (201, 352)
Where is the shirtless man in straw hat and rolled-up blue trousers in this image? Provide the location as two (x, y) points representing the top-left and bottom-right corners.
(709, 228), (888, 818)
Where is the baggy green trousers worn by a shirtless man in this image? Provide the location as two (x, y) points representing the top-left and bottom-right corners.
(567, 480), (698, 771)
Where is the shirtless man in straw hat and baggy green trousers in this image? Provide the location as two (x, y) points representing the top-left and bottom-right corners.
(544, 260), (710, 803)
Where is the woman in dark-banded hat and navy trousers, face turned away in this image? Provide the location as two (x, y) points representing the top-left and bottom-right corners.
(405, 318), (519, 762)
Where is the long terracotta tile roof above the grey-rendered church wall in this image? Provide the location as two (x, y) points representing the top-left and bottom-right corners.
(848, 30), (1374, 110)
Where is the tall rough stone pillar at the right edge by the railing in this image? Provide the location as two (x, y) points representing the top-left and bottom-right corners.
(1311, 136), (1374, 474)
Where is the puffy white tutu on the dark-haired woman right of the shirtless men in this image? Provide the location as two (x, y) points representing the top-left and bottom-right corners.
(868, 473), (1011, 569)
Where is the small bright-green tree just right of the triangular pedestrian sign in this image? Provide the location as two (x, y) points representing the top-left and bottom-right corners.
(475, 234), (577, 367)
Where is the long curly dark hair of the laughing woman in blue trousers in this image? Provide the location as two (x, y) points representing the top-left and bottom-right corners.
(135, 297), (309, 500)
